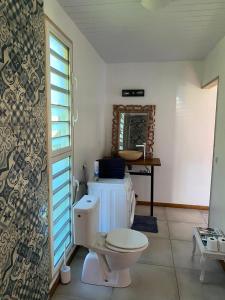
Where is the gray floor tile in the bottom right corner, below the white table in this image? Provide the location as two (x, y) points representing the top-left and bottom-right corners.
(176, 269), (225, 300)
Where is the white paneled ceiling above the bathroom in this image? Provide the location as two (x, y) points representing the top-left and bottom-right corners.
(58, 0), (225, 63)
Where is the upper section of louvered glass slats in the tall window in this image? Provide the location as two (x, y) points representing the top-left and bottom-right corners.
(49, 33), (71, 151)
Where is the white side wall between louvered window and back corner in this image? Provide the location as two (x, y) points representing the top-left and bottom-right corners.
(44, 0), (106, 188)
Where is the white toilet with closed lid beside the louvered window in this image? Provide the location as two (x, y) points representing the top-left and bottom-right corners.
(73, 195), (148, 287)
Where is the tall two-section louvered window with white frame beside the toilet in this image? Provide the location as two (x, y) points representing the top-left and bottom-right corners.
(47, 20), (73, 273)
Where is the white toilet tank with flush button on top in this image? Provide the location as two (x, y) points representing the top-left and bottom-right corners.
(73, 195), (99, 248)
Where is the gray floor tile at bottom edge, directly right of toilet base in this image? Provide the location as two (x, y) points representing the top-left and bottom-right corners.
(111, 264), (179, 300)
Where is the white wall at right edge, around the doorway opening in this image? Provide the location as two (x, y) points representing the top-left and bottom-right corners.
(203, 37), (225, 232)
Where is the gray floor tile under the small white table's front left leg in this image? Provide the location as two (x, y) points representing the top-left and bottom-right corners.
(171, 240), (223, 272)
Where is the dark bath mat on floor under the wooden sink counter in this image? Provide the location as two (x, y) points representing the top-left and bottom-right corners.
(131, 215), (158, 233)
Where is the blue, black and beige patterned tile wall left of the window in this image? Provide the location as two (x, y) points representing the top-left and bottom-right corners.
(0, 0), (49, 300)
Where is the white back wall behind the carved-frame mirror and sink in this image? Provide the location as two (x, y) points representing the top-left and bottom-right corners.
(105, 62), (216, 205)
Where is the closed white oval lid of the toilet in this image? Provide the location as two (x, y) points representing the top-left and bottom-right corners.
(106, 228), (148, 250)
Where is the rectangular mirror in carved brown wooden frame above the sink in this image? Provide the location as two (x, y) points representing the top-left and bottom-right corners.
(112, 105), (155, 158)
